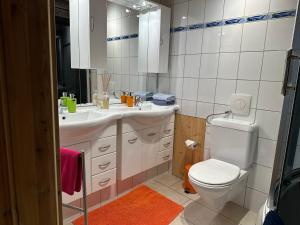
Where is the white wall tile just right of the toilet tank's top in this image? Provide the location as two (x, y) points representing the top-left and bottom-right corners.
(256, 110), (281, 140)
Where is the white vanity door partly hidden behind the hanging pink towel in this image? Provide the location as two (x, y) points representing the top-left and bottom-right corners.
(62, 142), (92, 203)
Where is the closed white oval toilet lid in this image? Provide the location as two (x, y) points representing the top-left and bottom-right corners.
(189, 159), (240, 185)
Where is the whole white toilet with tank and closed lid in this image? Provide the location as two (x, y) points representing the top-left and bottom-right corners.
(188, 118), (258, 210)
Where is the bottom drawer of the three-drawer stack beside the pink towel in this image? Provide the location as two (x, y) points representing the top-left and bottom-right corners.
(92, 169), (116, 192)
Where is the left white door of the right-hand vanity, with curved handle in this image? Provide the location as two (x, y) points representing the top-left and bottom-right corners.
(119, 132), (142, 180)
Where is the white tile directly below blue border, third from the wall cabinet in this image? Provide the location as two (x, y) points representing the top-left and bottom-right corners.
(202, 27), (221, 53)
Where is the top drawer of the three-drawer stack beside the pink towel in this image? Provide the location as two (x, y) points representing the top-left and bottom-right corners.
(92, 136), (116, 158)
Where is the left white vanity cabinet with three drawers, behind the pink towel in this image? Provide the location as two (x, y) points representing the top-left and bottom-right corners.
(61, 121), (117, 203)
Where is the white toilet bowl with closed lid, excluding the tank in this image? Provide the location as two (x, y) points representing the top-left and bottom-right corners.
(189, 159), (248, 211)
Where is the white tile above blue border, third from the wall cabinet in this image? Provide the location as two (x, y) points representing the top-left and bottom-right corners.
(205, 0), (224, 22)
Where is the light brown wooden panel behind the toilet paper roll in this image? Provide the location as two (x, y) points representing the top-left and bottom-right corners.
(173, 114), (206, 177)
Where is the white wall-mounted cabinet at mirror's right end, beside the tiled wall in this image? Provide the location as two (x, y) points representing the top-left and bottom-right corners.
(138, 6), (171, 73)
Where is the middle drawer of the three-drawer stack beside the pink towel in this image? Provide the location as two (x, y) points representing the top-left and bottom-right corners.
(92, 152), (116, 175)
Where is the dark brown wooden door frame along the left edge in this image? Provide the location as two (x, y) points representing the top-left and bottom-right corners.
(0, 0), (62, 225)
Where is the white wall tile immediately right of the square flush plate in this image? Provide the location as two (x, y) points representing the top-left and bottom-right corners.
(257, 81), (283, 111)
